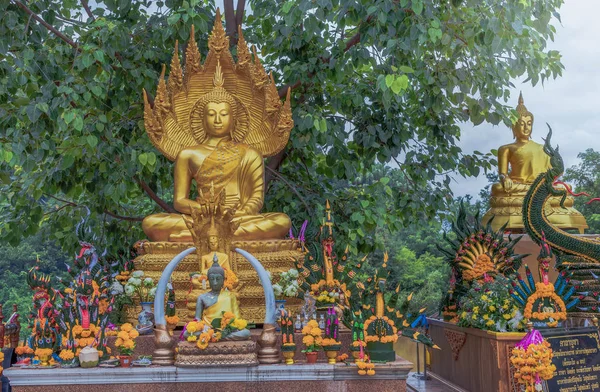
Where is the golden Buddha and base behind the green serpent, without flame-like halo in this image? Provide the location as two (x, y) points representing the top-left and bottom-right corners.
(483, 94), (588, 234)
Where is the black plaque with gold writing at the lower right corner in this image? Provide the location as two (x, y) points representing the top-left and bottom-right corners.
(540, 327), (600, 392)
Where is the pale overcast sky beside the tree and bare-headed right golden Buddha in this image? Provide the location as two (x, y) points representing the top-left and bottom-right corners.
(451, 0), (600, 196)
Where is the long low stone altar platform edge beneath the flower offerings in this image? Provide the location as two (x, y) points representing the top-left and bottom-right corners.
(5, 358), (412, 392)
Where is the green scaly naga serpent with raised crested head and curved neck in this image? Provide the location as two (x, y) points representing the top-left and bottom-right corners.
(523, 125), (600, 318)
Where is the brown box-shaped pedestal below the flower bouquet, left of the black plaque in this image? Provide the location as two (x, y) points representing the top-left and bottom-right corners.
(429, 319), (525, 392)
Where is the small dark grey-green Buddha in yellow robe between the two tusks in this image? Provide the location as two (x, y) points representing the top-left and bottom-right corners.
(196, 261), (250, 340)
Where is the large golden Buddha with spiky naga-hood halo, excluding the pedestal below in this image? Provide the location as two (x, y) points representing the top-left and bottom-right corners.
(142, 15), (293, 242)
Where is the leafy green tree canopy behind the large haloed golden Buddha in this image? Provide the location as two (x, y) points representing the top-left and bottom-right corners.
(0, 0), (563, 254)
